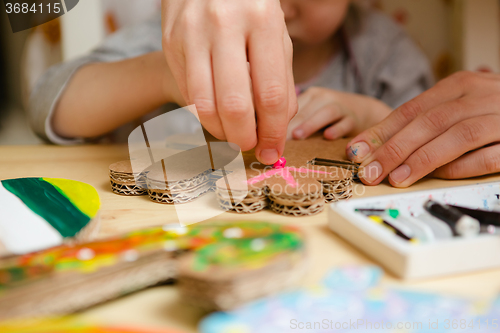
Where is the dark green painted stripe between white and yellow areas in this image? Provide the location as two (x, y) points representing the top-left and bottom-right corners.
(2, 178), (90, 237)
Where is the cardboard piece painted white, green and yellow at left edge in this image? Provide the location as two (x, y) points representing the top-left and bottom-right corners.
(0, 178), (100, 257)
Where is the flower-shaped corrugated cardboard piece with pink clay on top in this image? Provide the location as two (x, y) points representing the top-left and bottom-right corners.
(216, 136), (353, 216)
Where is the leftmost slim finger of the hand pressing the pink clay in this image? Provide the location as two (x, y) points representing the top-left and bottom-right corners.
(186, 49), (226, 140)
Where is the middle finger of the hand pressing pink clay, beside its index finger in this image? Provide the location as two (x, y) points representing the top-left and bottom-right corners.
(212, 31), (257, 151)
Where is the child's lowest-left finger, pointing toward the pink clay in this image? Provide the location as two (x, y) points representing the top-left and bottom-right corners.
(292, 104), (344, 140)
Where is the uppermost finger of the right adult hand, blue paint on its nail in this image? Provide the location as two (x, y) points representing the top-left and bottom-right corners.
(346, 73), (468, 163)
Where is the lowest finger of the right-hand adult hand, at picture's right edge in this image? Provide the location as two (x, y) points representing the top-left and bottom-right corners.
(432, 144), (500, 179)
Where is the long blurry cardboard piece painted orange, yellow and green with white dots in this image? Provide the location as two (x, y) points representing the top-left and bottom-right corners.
(0, 222), (306, 320)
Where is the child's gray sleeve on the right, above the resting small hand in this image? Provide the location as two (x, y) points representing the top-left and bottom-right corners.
(345, 6), (434, 108)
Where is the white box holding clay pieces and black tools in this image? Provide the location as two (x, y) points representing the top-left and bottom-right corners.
(328, 183), (500, 279)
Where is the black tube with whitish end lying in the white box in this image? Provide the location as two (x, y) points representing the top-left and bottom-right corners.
(424, 200), (480, 237)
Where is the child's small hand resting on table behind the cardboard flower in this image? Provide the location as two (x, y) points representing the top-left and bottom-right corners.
(288, 87), (391, 140)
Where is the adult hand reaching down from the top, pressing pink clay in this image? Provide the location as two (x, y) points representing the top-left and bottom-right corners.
(162, 0), (297, 164)
